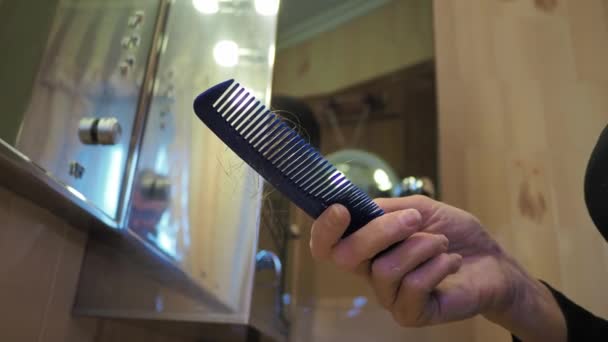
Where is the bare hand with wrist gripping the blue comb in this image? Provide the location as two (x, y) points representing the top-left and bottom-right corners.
(310, 196), (565, 340)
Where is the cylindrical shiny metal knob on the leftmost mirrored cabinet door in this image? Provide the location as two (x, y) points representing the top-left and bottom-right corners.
(78, 117), (122, 145)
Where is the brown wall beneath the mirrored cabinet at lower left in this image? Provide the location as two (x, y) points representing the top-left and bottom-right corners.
(0, 187), (216, 342)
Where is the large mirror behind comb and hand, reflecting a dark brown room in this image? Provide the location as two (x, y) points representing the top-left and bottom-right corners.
(273, 0), (438, 341)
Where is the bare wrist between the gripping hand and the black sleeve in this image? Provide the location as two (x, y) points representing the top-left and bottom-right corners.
(484, 255), (567, 342)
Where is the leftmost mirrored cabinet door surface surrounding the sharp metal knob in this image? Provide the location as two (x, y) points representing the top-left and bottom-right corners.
(13, 0), (159, 220)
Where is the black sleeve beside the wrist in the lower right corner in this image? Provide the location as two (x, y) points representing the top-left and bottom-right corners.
(513, 282), (608, 342)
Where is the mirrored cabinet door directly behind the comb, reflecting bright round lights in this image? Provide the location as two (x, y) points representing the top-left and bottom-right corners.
(121, 0), (278, 313)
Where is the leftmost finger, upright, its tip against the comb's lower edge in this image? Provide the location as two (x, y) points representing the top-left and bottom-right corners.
(310, 204), (350, 259)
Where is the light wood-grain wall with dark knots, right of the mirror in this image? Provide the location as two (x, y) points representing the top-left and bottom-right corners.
(435, 0), (608, 341)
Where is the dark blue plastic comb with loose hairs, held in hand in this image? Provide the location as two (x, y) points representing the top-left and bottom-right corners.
(194, 80), (384, 237)
